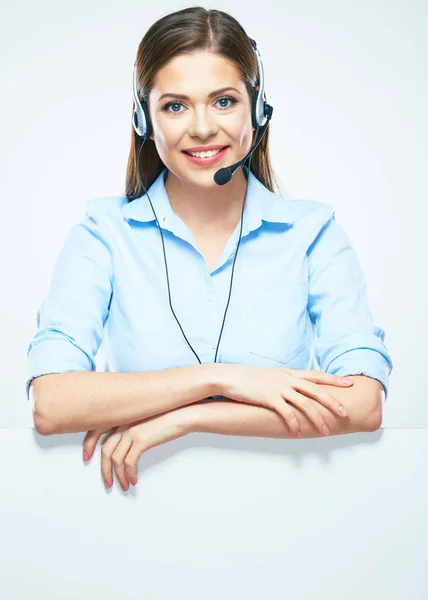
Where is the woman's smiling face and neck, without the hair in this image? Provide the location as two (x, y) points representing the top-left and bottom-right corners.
(140, 47), (255, 227)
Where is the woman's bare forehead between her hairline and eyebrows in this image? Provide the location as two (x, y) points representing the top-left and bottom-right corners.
(153, 51), (245, 96)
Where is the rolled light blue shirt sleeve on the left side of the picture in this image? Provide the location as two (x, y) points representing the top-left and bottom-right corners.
(26, 202), (113, 400)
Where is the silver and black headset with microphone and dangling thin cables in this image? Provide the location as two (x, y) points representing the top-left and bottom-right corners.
(132, 38), (273, 364)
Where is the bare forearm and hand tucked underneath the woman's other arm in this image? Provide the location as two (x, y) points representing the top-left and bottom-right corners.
(78, 375), (385, 491)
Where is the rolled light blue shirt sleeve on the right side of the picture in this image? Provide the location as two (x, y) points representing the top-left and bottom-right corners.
(307, 210), (393, 400)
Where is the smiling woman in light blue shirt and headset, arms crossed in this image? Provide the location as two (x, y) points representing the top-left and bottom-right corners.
(27, 7), (392, 490)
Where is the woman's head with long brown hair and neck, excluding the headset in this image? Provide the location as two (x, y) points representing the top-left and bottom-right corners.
(125, 7), (279, 206)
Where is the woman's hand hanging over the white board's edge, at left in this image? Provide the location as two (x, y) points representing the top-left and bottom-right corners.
(83, 409), (189, 491)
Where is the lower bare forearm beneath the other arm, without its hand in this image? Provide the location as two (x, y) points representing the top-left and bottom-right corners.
(182, 376), (376, 439)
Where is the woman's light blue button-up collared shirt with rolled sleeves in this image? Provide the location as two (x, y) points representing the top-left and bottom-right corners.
(26, 167), (392, 399)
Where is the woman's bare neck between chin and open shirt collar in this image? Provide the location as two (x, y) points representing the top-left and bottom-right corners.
(165, 167), (248, 232)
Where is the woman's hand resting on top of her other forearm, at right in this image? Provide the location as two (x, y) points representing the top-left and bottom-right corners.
(217, 364), (354, 437)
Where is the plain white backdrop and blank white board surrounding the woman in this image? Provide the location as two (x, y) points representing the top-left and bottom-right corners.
(0, 0), (428, 600)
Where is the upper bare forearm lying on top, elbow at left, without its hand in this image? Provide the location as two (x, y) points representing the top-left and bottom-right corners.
(30, 363), (219, 435)
